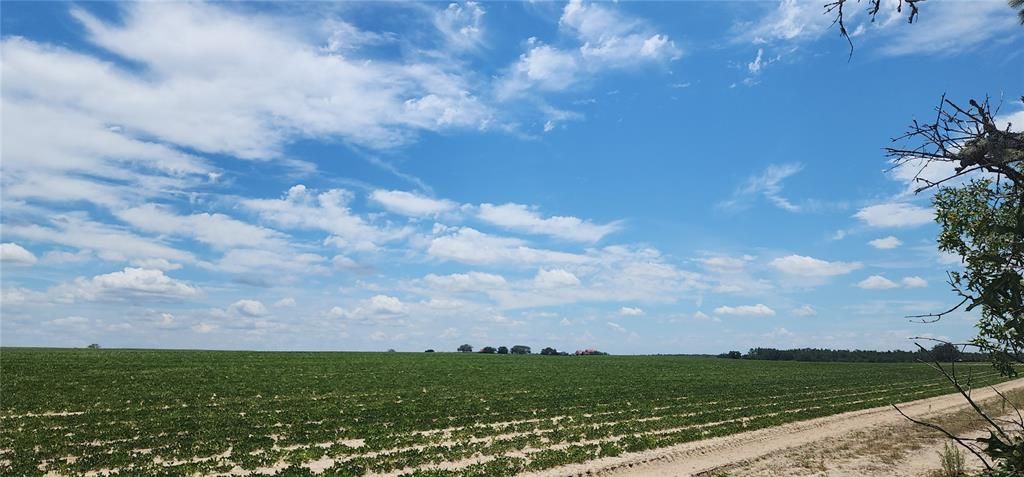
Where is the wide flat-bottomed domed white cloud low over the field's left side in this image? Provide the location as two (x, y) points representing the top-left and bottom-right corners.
(51, 267), (201, 301)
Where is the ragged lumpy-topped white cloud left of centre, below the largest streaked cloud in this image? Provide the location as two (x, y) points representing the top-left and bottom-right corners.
(242, 184), (410, 252)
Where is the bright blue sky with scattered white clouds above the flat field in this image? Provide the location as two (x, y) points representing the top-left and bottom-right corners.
(0, 0), (1024, 354)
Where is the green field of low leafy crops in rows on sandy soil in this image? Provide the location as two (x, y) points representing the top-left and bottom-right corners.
(0, 348), (1001, 476)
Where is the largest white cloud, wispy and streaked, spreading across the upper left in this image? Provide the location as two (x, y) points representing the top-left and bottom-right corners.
(50, 3), (487, 158)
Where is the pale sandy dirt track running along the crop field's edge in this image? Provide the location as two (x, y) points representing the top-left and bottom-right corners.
(522, 378), (1024, 477)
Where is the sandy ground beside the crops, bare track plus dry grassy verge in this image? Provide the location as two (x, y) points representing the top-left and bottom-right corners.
(531, 379), (1024, 477)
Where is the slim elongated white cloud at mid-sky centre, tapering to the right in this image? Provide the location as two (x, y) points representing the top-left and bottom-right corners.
(479, 204), (621, 242)
